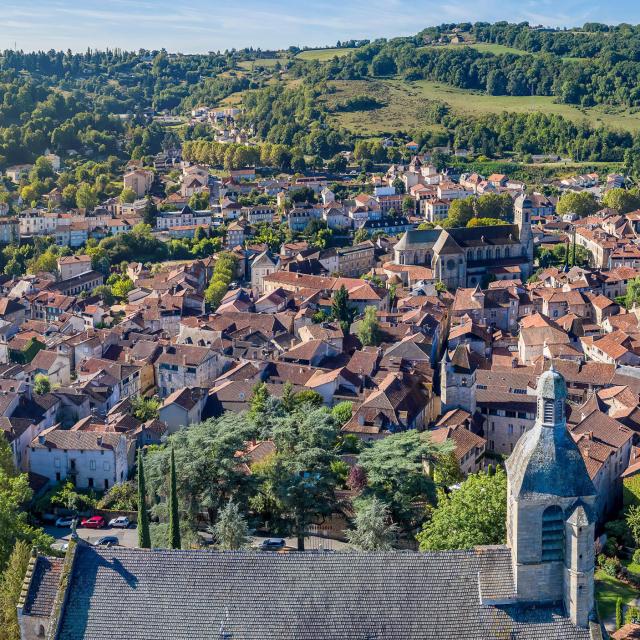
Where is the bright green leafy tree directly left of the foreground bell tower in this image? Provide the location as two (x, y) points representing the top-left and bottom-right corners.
(417, 468), (507, 551)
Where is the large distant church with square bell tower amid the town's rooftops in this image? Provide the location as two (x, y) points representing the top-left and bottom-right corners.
(393, 194), (534, 289)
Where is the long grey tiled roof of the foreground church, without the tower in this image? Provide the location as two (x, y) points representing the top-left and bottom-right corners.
(58, 545), (589, 640)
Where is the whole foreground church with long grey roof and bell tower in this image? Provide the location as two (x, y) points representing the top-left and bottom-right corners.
(18, 370), (602, 640)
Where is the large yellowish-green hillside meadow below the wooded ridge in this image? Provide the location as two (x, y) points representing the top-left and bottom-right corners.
(327, 80), (640, 136)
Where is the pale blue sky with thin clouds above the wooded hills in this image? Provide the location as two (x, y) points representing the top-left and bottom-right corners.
(0, 0), (640, 53)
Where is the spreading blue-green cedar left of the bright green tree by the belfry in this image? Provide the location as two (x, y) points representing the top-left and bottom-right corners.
(358, 429), (452, 530)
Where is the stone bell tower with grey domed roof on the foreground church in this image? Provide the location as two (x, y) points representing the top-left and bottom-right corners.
(507, 368), (596, 627)
